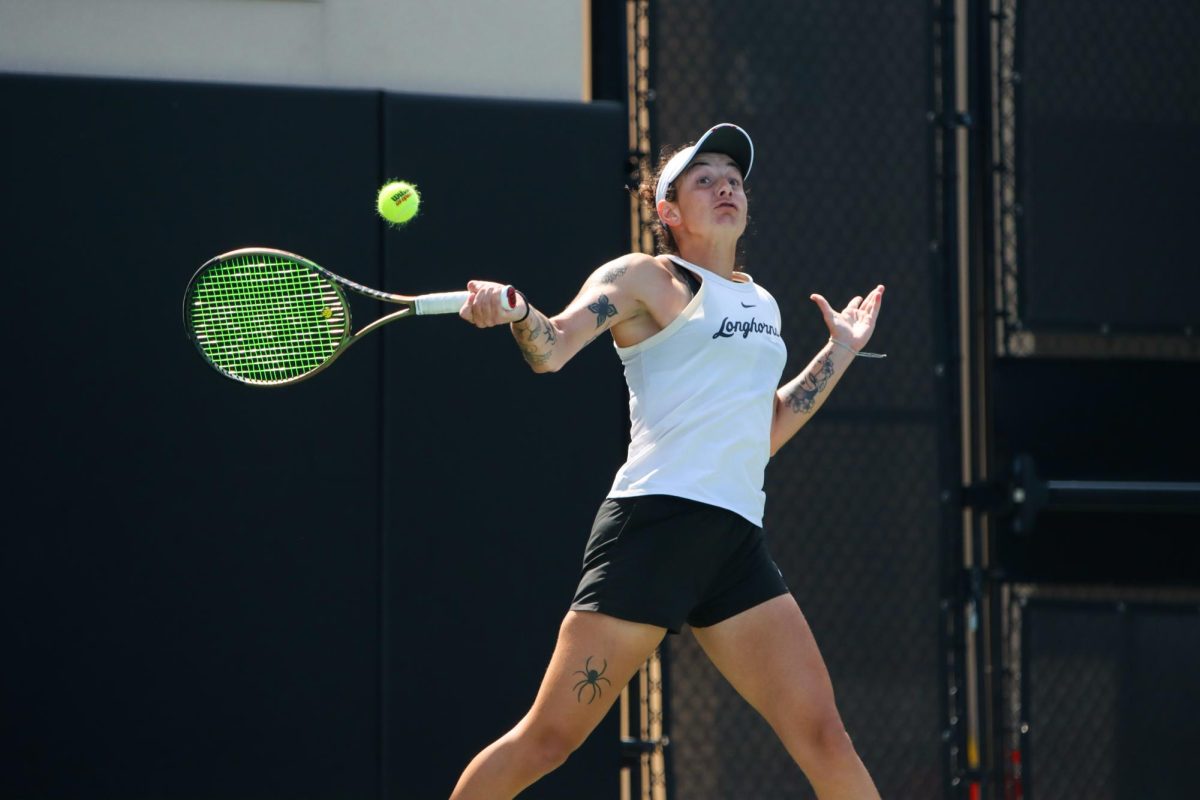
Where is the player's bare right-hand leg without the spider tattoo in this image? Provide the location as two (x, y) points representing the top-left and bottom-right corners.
(692, 595), (880, 800)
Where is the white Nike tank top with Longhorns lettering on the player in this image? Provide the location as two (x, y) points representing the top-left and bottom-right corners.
(608, 255), (787, 527)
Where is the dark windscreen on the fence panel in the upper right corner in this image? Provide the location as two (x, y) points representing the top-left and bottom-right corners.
(1016, 0), (1200, 332)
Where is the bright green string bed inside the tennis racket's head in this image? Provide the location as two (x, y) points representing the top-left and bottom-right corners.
(192, 254), (348, 383)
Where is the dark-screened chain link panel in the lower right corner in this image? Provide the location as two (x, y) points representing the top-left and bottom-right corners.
(1003, 584), (1200, 800)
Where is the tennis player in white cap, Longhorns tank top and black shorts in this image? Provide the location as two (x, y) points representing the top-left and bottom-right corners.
(451, 124), (883, 800)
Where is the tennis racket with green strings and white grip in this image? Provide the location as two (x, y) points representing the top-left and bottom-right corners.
(184, 247), (516, 386)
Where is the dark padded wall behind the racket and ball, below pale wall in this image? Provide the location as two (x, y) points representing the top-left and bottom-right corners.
(0, 76), (628, 798)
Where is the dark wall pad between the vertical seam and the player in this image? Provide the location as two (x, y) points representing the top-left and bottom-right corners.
(382, 90), (629, 799)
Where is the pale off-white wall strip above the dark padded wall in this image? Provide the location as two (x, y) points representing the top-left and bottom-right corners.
(0, 0), (586, 100)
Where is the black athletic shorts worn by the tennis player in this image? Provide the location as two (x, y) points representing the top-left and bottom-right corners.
(571, 494), (787, 633)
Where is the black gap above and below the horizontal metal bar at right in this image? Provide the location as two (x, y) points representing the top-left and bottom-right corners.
(994, 359), (1200, 585)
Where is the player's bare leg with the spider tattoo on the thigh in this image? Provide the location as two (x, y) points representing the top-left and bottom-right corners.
(450, 610), (666, 800)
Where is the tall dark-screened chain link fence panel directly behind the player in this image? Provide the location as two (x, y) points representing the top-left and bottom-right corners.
(650, 0), (942, 800)
